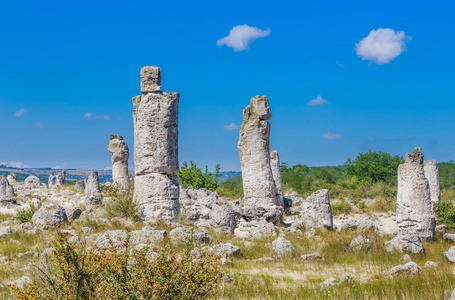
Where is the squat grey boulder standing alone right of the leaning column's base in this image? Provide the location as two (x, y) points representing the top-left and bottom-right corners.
(300, 190), (333, 230)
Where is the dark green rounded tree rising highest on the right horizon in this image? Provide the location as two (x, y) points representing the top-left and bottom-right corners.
(344, 151), (404, 185)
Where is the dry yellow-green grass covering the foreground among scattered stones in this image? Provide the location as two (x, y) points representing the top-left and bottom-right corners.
(0, 215), (455, 299)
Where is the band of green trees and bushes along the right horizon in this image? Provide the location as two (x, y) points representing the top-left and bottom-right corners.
(217, 151), (455, 205)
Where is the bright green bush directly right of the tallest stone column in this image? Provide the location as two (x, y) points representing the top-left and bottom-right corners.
(178, 160), (221, 191)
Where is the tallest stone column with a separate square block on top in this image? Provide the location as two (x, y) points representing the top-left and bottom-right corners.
(133, 67), (180, 220)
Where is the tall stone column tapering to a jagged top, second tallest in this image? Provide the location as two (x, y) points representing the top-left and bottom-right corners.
(237, 96), (283, 222)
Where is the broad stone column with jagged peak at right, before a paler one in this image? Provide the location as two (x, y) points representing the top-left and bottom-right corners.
(397, 147), (436, 241)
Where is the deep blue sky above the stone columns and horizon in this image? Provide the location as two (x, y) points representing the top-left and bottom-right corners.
(0, 1), (455, 171)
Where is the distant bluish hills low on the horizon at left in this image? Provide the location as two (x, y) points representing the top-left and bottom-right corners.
(0, 165), (242, 183)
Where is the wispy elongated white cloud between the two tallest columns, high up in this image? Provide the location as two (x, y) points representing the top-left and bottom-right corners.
(216, 25), (270, 51)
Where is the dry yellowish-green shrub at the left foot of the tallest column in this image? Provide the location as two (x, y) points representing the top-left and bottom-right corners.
(105, 184), (137, 218)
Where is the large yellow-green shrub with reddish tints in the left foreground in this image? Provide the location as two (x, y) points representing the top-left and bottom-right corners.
(10, 232), (224, 300)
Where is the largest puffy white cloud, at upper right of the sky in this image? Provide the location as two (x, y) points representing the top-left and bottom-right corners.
(355, 28), (411, 65)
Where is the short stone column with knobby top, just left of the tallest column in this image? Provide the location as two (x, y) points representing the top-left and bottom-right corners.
(107, 134), (130, 188)
